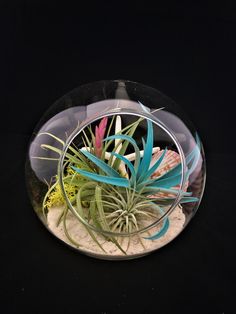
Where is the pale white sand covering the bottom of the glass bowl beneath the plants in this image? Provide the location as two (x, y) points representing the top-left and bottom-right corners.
(48, 206), (185, 259)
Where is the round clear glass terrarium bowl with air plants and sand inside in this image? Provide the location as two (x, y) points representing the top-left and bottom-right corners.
(26, 80), (205, 260)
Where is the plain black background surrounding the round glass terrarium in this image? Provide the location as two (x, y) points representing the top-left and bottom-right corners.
(0, 0), (236, 314)
